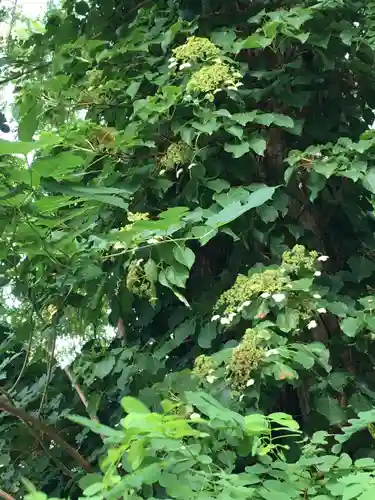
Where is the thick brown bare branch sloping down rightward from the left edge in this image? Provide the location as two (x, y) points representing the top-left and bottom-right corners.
(0, 399), (92, 472)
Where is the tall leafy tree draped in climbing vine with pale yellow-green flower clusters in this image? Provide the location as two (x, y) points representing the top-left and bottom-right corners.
(0, 0), (375, 500)
